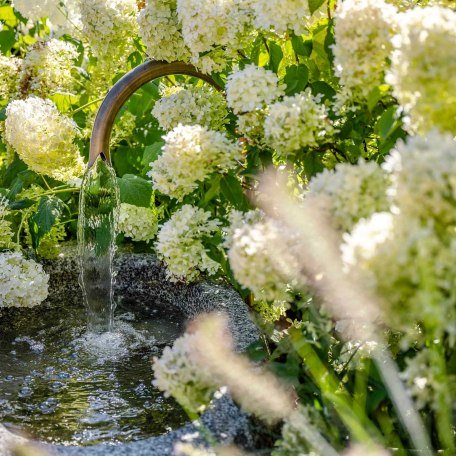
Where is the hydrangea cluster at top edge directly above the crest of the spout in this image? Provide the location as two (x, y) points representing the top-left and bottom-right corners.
(138, 0), (190, 62)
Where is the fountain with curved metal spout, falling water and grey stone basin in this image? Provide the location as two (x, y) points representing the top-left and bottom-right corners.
(0, 62), (258, 456)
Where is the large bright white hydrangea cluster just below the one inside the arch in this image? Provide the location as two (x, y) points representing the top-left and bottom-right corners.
(147, 124), (241, 201)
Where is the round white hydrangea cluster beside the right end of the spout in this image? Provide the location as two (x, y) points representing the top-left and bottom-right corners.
(226, 64), (285, 114)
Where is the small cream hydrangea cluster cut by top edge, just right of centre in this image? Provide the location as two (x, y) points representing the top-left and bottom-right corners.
(253, 0), (310, 35)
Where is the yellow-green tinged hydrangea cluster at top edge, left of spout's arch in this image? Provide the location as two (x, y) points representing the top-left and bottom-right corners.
(79, 0), (138, 60)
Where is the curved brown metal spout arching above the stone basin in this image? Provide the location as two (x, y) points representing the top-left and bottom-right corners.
(88, 61), (220, 168)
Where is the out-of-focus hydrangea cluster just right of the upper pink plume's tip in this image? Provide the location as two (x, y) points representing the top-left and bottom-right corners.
(308, 159), (389, 231)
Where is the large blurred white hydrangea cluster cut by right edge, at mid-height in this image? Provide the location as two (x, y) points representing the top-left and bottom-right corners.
(383, 131), (456, 224)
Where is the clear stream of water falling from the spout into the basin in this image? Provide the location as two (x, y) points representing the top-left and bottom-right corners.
(78, 157), (119, 333)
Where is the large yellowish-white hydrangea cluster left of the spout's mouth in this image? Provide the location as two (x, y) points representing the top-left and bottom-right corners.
(5, 97), (84, 182)
